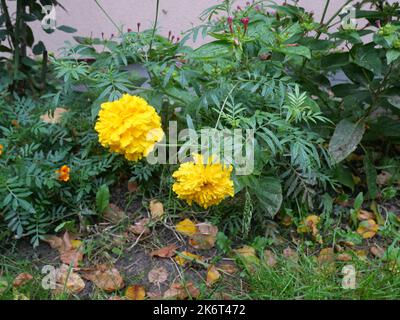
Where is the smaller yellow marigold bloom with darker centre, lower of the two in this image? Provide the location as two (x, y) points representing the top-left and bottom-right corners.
(172, 154), (234, 209)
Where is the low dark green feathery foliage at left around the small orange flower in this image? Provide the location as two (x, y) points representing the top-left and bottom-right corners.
(0, 91), (122, 245)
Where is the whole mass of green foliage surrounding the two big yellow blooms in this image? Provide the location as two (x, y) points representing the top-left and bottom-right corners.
(0, 0), (400, 244)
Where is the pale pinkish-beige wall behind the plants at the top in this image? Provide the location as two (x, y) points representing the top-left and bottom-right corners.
(33, 0), (345, 52)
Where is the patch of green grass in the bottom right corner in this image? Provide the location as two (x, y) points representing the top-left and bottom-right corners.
(246, 255), (400, 300)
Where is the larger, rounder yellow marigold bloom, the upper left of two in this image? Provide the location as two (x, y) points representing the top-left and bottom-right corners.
(95, 94), (164, 161)
